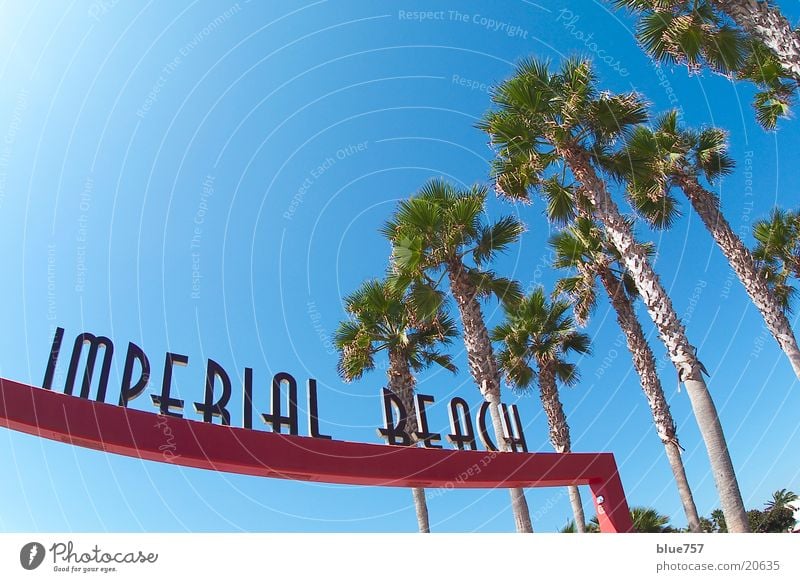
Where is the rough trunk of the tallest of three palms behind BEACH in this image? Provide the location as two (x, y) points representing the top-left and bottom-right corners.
(447, 259), (533, 533)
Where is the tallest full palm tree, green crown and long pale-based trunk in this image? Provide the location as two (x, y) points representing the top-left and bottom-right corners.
(480, 59), (748, 532)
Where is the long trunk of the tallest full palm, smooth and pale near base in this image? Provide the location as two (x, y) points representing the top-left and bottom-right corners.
(559, 147), (749, 533)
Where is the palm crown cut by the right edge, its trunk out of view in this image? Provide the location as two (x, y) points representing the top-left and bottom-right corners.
(753, 208), (800, 313)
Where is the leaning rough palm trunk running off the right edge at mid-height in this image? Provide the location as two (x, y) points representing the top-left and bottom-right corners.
(677, 175), (800, 379)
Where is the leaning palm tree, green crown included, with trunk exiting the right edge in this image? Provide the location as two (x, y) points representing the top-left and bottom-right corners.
(614, 111), (800, 378)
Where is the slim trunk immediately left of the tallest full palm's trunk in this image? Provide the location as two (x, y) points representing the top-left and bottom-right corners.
(597, 264), (701, 533)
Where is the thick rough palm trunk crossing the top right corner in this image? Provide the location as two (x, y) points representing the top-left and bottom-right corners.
(714, 0), (800, 79)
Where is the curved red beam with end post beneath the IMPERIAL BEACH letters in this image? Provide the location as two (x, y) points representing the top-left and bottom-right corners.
(0, 379), (631, 532)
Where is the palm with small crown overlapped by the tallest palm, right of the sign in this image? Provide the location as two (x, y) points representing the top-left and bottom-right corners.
(550, 218), (700, 532)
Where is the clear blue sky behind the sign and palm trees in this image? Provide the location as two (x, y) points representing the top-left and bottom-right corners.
(0, 0), (800, 532)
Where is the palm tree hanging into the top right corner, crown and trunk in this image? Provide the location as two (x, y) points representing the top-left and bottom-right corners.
(613, 0), (800, 129)
